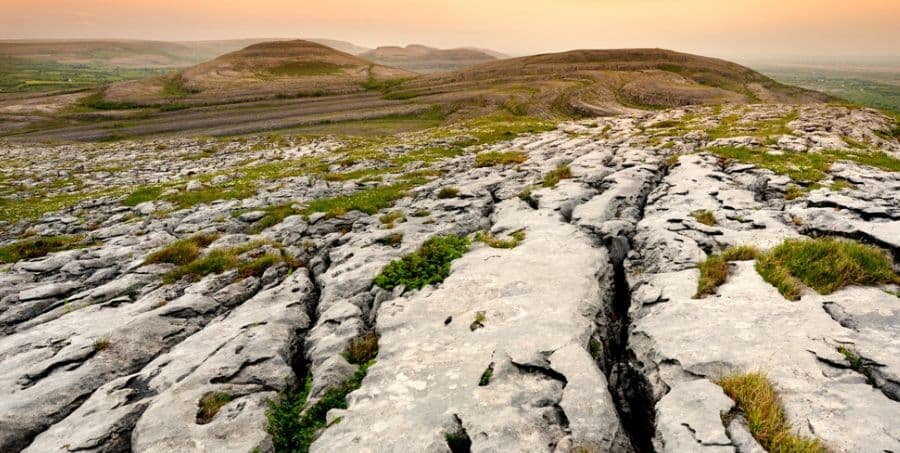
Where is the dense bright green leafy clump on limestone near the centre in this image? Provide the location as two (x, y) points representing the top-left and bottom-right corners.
(374, 235), (469, 291)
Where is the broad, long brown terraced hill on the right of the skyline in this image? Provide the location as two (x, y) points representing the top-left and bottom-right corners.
(390, 49), (828, 116)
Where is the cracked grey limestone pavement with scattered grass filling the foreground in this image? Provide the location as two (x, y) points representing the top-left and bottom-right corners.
(0, 105), (900, 452)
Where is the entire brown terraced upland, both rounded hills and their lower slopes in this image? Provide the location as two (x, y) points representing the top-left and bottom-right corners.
(0, 46), (831, 141)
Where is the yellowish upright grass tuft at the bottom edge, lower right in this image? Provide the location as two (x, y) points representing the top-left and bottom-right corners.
(718, 372), (827, 453)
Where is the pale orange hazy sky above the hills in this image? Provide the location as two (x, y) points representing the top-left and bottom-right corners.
(0, 0), (900, 56)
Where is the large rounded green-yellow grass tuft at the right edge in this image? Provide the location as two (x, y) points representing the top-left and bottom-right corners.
(756, 238), (900, 300)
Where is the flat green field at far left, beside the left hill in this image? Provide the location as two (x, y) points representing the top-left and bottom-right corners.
(0, 57), (177, 93)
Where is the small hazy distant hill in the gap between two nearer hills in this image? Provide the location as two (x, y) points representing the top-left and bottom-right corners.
(359, 44), (497, 73)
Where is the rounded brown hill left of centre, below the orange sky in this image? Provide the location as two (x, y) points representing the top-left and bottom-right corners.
(104, 40), (414, 104)
